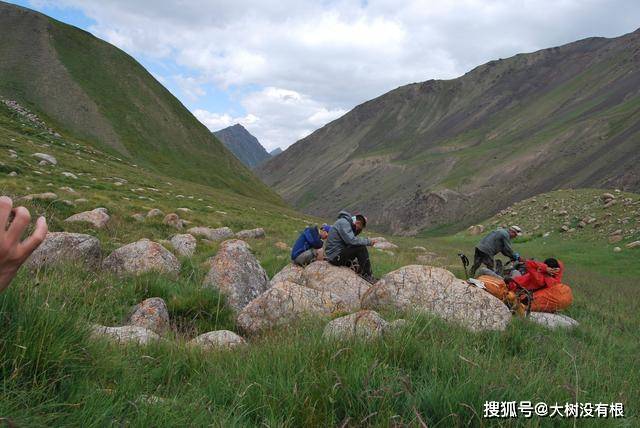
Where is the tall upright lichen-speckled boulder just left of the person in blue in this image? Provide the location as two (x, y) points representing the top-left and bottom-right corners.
(204, 239), (269, 311)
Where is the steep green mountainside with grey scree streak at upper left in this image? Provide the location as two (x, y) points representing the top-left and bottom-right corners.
(0, 2), (279, 203)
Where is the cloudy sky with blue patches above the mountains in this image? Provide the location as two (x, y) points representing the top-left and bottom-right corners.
(14, 0), (640, 150)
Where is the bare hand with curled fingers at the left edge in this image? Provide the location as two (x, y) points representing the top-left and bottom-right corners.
(0, 196), (47, 293)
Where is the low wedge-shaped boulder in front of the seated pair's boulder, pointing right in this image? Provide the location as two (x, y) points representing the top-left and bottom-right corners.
(237, 282), (347, 334)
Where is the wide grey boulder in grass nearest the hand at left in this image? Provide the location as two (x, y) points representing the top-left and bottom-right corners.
(26, 232), (102, 269)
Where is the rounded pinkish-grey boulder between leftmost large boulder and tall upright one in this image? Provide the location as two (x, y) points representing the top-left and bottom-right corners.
(102, 239), (180, 276)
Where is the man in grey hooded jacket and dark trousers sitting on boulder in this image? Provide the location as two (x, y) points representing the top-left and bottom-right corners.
(325, 211), (376, 283)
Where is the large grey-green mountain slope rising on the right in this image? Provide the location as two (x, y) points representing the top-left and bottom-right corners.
(257, 27), (640, 234)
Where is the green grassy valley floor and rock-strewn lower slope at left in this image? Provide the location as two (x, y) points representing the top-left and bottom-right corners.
(0, 105), (640, 427)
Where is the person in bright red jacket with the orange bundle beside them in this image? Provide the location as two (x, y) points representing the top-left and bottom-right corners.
(508, 258), (573, 312)
